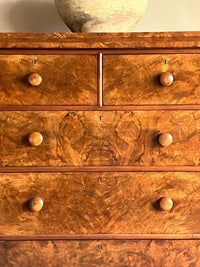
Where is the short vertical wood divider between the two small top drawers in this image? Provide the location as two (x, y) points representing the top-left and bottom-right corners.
(97, 53), (103, 107)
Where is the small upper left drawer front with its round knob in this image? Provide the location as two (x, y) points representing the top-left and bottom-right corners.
(0, 55), (97, 105)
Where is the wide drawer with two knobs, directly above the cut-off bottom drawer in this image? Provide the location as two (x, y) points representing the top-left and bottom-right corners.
(0, 172), (200, 235)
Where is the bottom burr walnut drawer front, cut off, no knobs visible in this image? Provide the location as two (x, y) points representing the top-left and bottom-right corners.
(0, 240), (200, 267)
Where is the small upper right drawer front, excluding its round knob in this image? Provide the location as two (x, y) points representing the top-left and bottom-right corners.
(103, 54), (200, 105)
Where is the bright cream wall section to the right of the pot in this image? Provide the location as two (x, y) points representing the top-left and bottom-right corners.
(135, 0), (200, 32)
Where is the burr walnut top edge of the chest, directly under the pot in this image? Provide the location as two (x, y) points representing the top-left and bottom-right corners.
(0, 31), (200, 50)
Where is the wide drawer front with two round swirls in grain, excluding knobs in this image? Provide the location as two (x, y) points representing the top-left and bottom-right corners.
(0, 110), (200, 166)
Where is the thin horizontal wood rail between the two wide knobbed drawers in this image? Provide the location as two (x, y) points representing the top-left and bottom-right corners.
(0, 166), (200, 173)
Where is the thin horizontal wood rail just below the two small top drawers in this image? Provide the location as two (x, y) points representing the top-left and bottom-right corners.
(0, 104), (200, 111)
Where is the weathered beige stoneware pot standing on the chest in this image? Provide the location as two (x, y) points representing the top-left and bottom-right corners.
(55, 0), (148, 32)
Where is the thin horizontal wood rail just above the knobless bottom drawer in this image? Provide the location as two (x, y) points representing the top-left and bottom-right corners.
(0, 234), (200, 241)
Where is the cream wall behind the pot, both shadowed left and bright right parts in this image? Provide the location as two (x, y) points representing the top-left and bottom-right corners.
(0, 0), (200, 32)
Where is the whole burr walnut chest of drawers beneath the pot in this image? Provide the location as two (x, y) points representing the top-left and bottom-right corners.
(0, 32), (200, 267)
